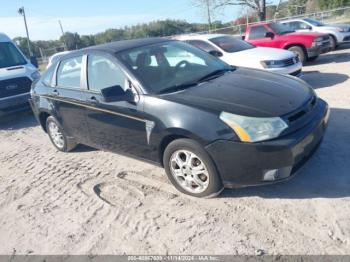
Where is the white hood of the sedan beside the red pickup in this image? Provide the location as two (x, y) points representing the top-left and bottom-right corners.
(227, 47), (295, 62)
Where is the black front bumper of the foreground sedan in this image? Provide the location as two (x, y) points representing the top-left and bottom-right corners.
(206, 100), (329, 187)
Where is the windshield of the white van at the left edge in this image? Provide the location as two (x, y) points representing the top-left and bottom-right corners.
(0, 42), (27, 68)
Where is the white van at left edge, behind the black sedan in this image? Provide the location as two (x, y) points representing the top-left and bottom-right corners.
(0, 33), (40, 116)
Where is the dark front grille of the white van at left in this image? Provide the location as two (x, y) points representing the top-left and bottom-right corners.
(0, 77), (32, 98)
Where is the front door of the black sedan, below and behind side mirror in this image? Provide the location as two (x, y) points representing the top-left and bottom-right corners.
(83, 52), (149, 157)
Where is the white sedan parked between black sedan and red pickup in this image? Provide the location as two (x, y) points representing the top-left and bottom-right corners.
(176, 34), (302, 76)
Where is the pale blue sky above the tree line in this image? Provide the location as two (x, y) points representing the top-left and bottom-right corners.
(0, 0), (247, 40)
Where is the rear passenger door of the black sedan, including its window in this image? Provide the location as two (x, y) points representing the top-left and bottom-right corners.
(49, 55), (89, 143)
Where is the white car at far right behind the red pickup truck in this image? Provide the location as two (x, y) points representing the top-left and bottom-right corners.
(281, 18), (350, 50)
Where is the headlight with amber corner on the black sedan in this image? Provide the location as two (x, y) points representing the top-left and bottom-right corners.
(220, 112), (288, 142)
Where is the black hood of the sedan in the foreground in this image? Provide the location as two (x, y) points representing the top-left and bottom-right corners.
(162, 68), (314, 117)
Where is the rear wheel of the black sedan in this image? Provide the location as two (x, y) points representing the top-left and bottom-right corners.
(46, 116), (77, 152)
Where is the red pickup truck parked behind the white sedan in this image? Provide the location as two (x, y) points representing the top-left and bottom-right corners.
(244, 23), (331, 64)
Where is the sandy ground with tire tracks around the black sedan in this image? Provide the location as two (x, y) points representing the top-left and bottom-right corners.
(0, 45), (350, 255)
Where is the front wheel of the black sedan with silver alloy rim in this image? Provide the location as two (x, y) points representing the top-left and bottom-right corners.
(163, 139), (224, 198)
